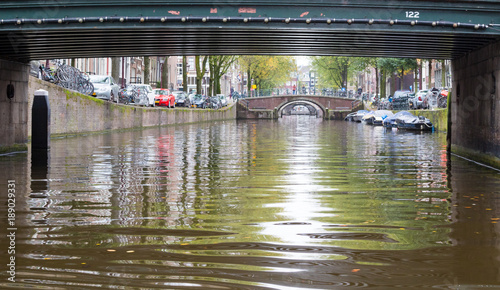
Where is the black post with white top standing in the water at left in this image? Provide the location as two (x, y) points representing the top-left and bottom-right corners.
(31, 90), (50, 150)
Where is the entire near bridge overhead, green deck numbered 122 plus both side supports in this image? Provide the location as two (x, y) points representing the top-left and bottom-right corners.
(0, 0), (500, 166)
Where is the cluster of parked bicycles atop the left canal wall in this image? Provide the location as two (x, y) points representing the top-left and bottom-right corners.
(40, 64), (94, 96)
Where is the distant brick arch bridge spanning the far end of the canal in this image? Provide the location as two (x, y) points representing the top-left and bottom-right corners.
(238, 95), (361, 119)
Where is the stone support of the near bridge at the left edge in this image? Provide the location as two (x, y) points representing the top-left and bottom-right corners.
(0, 60), (29, 153)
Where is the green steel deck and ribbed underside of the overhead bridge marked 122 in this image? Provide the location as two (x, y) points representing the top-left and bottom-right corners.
(0, 0), (500, 62)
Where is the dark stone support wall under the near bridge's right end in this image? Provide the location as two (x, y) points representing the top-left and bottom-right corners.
(450, 41), (500, 168)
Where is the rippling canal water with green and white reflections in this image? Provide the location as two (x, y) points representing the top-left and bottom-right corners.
(0, 116), (500, 289)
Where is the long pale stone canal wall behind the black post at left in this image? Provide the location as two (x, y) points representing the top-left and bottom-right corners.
(28, 76), (236, 137)
